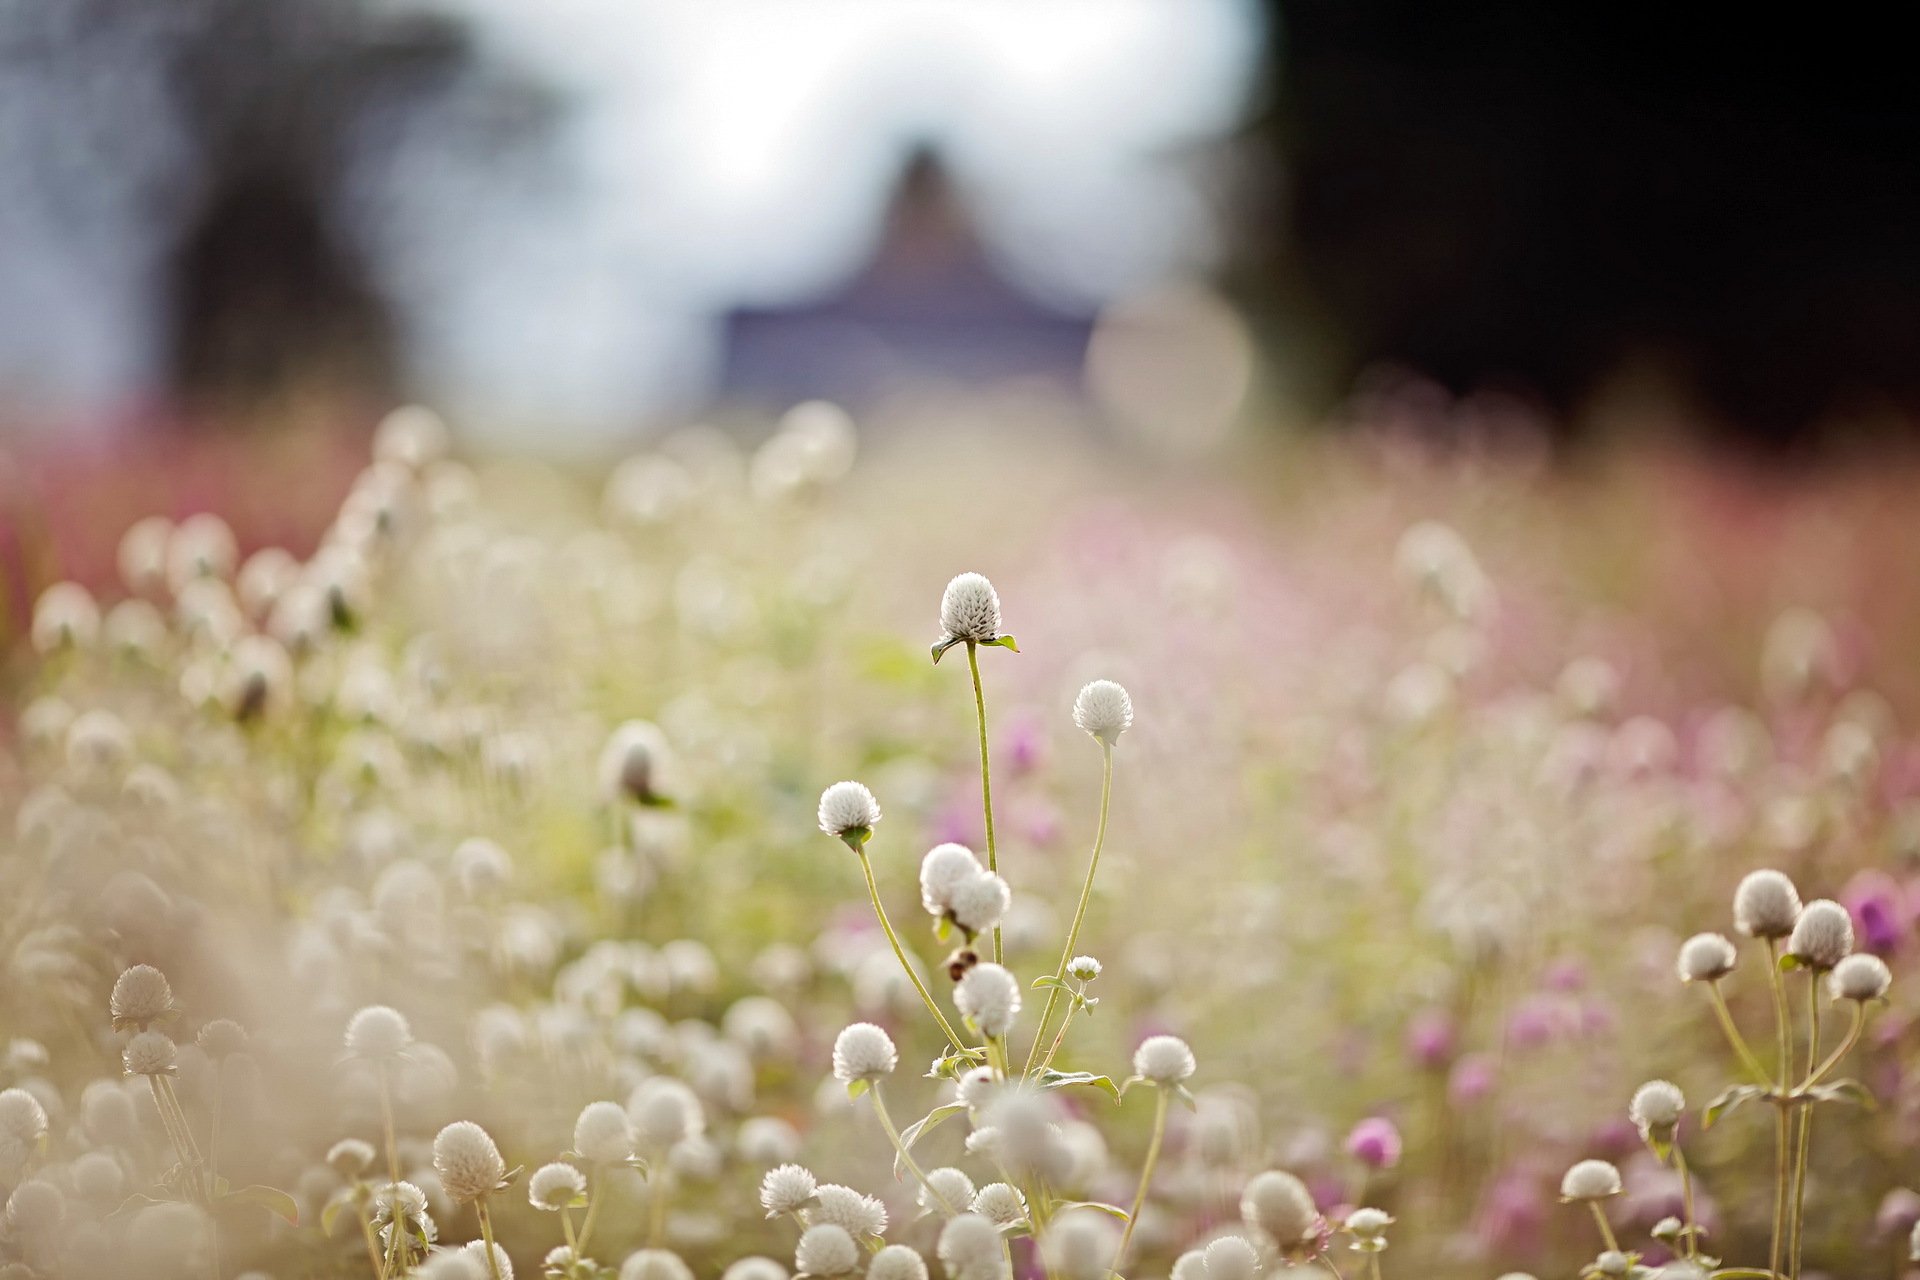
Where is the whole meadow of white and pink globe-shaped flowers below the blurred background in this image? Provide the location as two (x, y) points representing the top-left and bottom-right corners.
(0, 405), (1920, 1280)
